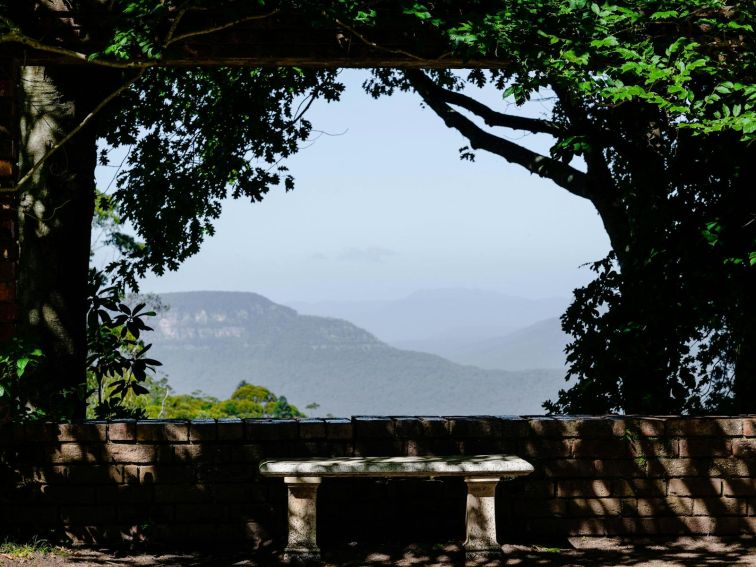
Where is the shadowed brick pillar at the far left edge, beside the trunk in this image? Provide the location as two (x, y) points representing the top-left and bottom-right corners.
(0, 59), (19, 342)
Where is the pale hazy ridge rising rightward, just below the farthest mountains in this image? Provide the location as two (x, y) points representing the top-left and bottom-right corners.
(392, 317), (570, 370)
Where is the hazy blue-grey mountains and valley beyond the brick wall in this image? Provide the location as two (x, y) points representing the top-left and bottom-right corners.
(148, 290), (564, 416)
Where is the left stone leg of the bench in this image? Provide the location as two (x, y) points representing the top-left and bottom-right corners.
(284, 476), (320, 562)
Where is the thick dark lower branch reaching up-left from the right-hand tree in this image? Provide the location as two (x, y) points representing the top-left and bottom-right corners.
(404, 70), (593, 200)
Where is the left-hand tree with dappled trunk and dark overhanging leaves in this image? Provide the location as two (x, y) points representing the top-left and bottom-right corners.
(3, 3), (341, 418)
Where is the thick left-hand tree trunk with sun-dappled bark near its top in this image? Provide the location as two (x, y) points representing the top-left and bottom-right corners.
(18, 67), (106, 419)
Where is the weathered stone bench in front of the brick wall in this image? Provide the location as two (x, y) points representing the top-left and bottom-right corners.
(260, 455), (533, 560)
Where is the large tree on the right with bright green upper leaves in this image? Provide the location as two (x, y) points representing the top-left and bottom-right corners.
(358, 0), (756, 413)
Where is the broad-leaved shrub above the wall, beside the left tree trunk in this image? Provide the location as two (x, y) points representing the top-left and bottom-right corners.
(87, 268), (161, 419)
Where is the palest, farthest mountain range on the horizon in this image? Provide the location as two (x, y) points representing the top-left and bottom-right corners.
(287, 288), (569, 343)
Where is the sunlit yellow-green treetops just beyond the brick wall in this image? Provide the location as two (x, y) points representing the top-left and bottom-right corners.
(116, 378), (304, 419)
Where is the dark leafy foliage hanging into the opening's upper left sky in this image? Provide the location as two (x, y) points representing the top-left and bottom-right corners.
(97, 68), (343, 288)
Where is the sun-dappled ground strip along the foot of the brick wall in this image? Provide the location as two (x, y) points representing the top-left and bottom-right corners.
(0, 537), (756, 567)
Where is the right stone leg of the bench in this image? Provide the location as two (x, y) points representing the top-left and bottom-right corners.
(465, 477), (501, 558)
